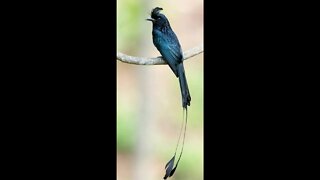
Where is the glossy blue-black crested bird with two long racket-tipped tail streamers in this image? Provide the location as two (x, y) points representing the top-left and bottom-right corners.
(147, 7), (191, 179)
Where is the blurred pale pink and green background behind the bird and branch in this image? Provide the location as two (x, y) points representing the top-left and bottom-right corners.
(117, 0), (203, 180)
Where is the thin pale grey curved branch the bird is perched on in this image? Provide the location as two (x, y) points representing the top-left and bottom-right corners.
(117, 45), (203, 65)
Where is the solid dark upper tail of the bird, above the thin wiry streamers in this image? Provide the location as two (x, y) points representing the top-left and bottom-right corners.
(178, 63), (191, 108)
